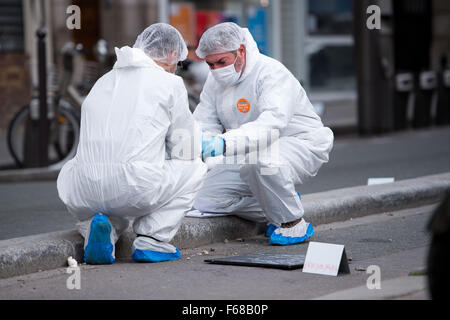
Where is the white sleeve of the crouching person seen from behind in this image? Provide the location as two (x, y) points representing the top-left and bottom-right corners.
(166, 78), (202, 160)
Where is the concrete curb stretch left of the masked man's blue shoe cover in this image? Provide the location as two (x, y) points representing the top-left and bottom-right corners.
(0, 217), (265, 279)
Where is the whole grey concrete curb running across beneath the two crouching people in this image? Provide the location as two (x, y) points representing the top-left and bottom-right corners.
(0, 173), (450, 278)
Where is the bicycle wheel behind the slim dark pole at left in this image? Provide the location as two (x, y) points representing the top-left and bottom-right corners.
(7, 100), (80, 168)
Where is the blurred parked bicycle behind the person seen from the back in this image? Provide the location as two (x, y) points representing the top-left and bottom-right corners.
(7, 40), (112, 168)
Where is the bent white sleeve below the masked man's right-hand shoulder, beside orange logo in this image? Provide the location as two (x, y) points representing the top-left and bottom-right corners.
(223, 70), (300, 156)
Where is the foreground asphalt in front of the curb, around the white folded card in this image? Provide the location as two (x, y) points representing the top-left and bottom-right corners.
(0, 206), (435, 300)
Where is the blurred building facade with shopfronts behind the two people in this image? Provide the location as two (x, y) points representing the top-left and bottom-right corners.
(0, 0), (450, 132)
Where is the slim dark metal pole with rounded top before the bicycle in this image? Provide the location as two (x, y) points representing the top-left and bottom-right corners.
(36, 28), (49, 167)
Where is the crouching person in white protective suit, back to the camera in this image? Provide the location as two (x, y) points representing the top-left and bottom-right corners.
(57, 23), (207, 264)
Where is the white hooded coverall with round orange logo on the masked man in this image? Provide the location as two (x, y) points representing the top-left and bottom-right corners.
(194, 28), (334, 224)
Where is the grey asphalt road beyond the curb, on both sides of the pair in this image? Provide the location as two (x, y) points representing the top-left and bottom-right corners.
(0, 127), (450, 240)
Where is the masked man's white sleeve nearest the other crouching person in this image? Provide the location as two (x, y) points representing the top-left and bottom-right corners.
(194, 73), (224, 137)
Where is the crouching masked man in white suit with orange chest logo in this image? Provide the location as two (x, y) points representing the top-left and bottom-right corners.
(194, 22), (334, 245)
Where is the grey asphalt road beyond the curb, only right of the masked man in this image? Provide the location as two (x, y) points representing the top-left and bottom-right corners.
(299, 127), (450, 193)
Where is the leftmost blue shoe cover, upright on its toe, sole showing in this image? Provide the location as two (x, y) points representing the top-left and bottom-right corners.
(84, 214), (115, 264)
